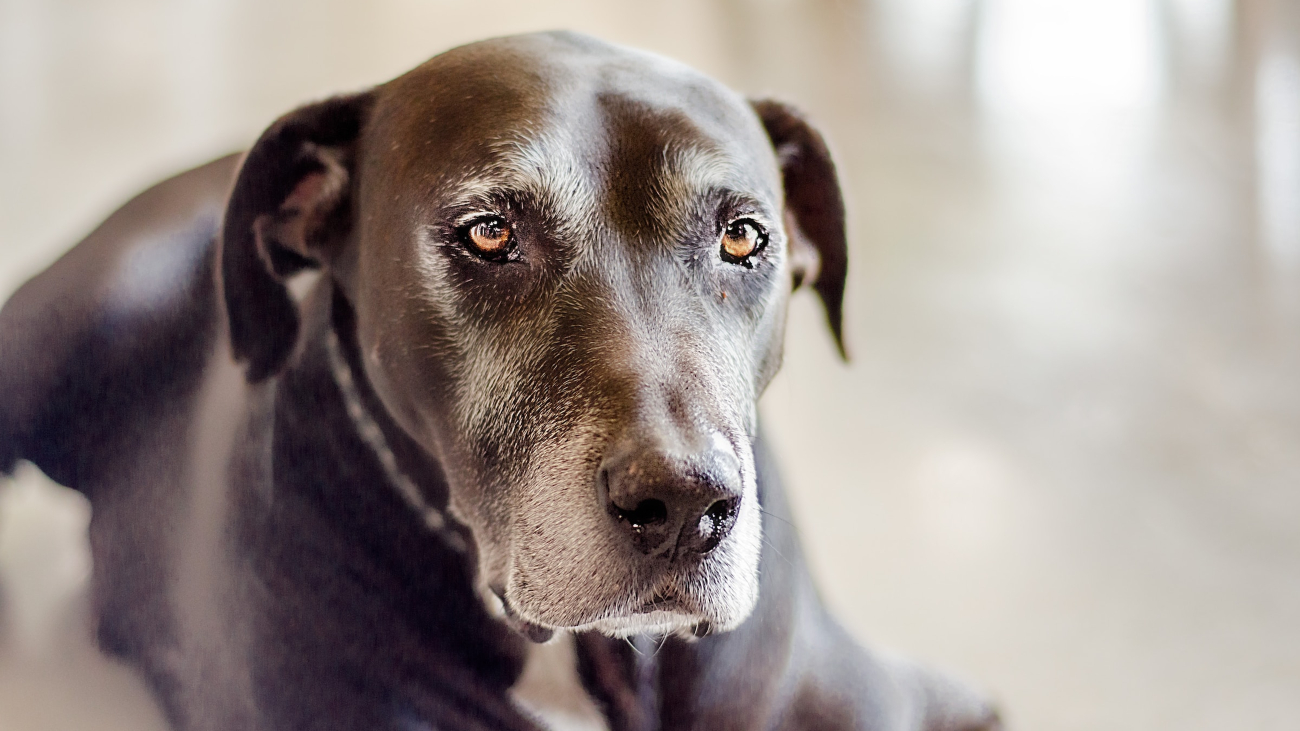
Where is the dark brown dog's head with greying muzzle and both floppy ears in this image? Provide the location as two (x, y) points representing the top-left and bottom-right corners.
(221, 34), (845, 635)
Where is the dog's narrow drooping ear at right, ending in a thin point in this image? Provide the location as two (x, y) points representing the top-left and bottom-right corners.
(750, 99), (849, 360)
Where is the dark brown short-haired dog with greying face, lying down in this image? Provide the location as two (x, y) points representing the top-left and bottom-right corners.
(0, 33), (1000, 731)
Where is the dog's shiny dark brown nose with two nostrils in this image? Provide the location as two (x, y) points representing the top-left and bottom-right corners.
(601, 447), (741, 558)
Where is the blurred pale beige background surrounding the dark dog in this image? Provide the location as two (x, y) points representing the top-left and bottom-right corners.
(0, 0), (1300, 731)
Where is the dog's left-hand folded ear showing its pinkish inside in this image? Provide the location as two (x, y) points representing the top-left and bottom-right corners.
(220, 92), (373, 382)
